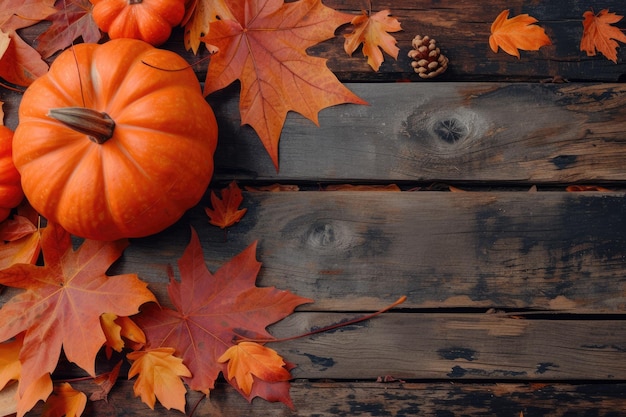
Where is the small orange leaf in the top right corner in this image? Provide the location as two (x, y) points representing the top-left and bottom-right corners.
(580, 9), (626, 64)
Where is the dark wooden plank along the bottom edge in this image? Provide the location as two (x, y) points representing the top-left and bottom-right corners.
(28, 381), (626, 417)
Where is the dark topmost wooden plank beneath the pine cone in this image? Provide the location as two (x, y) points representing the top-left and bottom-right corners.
(134, 0), (626, 82)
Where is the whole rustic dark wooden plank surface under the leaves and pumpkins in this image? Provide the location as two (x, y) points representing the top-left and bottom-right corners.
(0, 0), (626, 417)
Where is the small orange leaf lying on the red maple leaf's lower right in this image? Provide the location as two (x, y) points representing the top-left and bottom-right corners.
(217, 342), (291, 395)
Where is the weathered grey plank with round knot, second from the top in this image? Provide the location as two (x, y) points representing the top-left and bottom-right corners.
(209, 83), (626, 183)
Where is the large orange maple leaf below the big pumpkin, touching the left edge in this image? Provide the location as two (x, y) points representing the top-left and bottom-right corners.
(0, 224), (155, 412)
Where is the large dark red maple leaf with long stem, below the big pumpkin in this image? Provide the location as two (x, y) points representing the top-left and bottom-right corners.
(136, 230), (312, 406)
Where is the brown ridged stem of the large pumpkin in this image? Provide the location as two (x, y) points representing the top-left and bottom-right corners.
(48, 107), (115, 144)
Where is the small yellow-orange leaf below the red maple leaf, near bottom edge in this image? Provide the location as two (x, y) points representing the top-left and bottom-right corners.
(126, 347), (191, 413)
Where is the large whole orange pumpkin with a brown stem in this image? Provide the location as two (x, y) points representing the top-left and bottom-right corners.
(13, 39), (217, 240)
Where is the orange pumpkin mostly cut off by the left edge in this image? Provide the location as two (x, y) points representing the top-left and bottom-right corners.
(0, 126), (24, 222)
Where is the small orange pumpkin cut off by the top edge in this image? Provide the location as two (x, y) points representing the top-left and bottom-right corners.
(90, 0), (185, 46)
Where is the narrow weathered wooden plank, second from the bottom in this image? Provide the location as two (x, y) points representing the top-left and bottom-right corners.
(272, 312), (626, 381)
